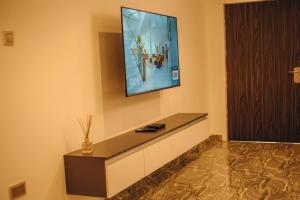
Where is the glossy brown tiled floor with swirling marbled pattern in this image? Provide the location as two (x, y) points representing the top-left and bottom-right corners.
(138, 142), (300, 200)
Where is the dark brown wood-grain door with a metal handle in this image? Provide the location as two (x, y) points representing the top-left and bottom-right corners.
(225, 0), (300, 142)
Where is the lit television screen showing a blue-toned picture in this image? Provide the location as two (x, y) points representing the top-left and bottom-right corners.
(121, 7), (180, 96)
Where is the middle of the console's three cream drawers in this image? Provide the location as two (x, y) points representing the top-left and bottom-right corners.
(144, 138), (172, 176)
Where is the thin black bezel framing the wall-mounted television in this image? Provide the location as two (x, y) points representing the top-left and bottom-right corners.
(121, 6), (181, 97)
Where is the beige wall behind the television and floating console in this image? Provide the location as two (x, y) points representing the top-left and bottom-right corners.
(0, 0), (209, 200)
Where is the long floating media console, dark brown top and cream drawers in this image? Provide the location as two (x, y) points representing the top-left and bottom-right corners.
(64, 113), (209, 198)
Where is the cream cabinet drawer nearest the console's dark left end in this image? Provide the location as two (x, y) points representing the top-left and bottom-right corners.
(106, 150), (145, 197)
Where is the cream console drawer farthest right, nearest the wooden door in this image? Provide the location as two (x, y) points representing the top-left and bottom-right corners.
(171, 120), (208, 159)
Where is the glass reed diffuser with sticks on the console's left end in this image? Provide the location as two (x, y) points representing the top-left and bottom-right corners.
(78, 115), (93, 154)
